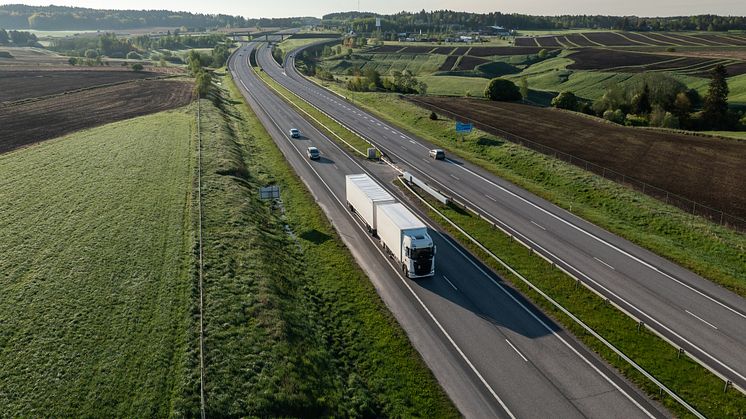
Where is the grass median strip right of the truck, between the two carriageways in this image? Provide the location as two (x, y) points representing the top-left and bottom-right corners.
(405, 182), (746, 417)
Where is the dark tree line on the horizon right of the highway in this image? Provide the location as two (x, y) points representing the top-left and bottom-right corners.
(321, 10), (746, 34)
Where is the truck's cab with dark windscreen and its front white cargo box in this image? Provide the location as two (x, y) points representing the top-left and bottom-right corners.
(375, 202), (435, 278)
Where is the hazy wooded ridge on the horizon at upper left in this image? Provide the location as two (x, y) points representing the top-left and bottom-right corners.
(0, 4), (319, 31)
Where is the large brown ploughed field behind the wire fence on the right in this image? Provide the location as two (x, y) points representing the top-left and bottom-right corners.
(404, 97), (746, 218)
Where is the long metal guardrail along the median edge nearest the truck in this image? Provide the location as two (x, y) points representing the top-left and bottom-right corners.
(402, 178), (705, 419)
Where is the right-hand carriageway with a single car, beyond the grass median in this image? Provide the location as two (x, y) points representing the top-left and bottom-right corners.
(257, 40), (746, 389)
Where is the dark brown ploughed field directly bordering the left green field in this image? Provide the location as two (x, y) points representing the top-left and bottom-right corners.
(0, 80), (193, 153)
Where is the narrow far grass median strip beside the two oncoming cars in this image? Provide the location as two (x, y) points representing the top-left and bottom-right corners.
(256, 65), (371, 155)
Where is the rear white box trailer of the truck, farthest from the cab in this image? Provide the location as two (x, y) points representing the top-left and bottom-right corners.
(345, 174), (396, 234)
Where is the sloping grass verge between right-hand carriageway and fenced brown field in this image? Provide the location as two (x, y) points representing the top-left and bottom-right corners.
(310, 87), (746, 296)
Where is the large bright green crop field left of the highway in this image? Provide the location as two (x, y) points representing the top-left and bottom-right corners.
(0, 106), (194, 417)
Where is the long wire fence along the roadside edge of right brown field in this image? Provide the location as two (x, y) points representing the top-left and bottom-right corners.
(407, 97), (746, 231)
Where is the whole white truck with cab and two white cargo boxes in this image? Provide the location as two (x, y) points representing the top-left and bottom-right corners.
(345, 174), (435, 278)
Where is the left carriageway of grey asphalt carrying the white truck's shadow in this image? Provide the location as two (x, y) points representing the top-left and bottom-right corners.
(229, 43), (670, 418)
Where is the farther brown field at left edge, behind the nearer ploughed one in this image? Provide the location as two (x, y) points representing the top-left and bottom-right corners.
(0, 68), (162, 102)
